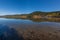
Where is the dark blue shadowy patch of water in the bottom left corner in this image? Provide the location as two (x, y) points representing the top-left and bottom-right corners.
(0, 25), (23, 40)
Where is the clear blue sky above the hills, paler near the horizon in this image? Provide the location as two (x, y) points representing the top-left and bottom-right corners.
(0, 0), (60, 15)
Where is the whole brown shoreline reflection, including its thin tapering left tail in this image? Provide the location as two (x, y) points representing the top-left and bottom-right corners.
(6, 18), (60, 22)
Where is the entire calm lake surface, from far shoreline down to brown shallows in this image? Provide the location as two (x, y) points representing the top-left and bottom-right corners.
(0, 18), (60, 40)
